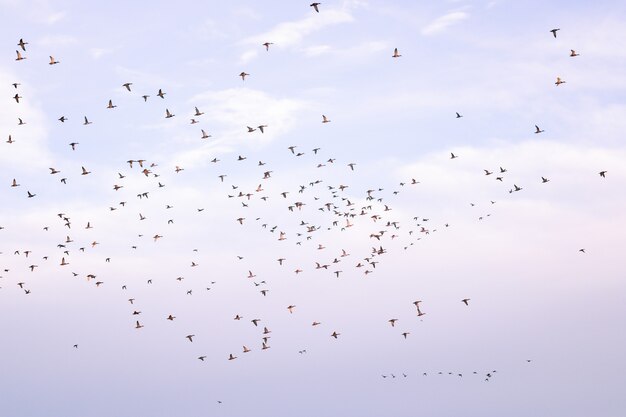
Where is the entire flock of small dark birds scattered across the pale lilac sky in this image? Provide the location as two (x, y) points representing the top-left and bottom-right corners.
(0, 3), (607, 394)
